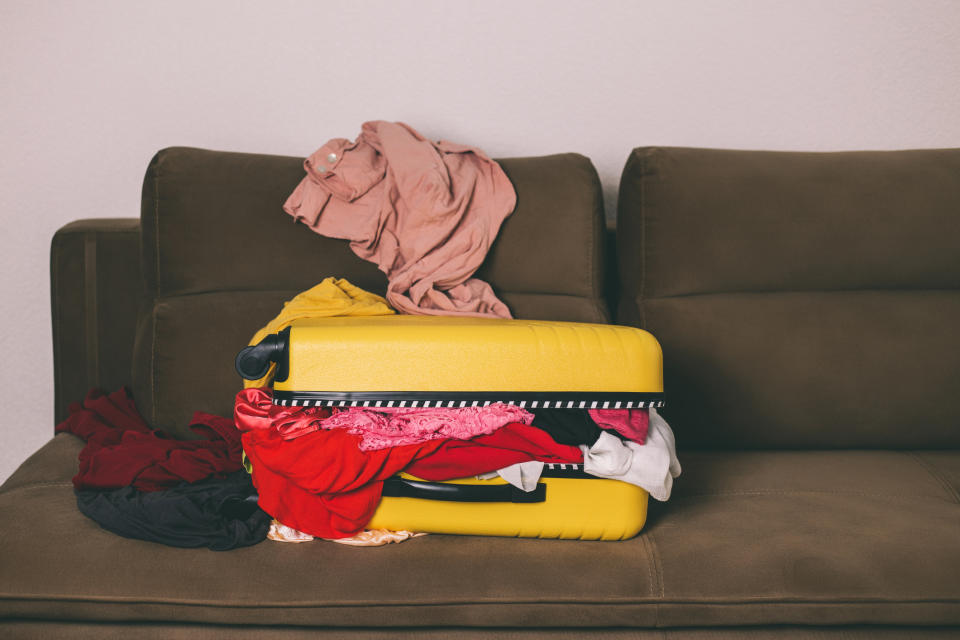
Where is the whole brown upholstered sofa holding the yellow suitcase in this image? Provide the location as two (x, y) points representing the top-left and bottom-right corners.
(0, 148), (960, 638)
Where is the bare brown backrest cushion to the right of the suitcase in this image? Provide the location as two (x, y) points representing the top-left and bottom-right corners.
(617, 147), (960, 448)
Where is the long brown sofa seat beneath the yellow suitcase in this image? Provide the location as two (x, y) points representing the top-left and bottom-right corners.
(0, 434), (960, 628)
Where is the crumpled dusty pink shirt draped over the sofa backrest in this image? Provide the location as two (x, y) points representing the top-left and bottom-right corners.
(283, 121), (516, 318)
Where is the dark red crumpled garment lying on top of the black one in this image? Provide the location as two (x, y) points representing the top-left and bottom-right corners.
(56, 388), (242, 491)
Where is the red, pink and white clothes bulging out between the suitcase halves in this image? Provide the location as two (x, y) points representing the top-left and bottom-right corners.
(234, 388), (680, 539)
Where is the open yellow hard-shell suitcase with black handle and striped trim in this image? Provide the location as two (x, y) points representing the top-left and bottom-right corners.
(236, 315), (663, 540)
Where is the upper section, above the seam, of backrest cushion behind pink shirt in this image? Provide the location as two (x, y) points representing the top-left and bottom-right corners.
(141, 147), (603, 306)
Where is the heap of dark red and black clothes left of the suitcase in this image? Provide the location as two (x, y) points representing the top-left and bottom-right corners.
(56, 389), (271, 551)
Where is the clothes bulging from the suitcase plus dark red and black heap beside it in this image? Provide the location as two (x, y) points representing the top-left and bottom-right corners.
(57, 380), (680, 550)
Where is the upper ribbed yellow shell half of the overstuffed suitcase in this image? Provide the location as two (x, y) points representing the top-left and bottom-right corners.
(274, 316), (663, 393)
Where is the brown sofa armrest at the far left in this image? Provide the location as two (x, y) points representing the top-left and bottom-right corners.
(50, 218), (143, 423)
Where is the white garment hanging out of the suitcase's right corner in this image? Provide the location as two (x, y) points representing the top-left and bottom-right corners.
(580, 409), (680, 501)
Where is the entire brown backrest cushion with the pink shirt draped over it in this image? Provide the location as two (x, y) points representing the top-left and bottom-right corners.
(134, 148), (609, 435)
